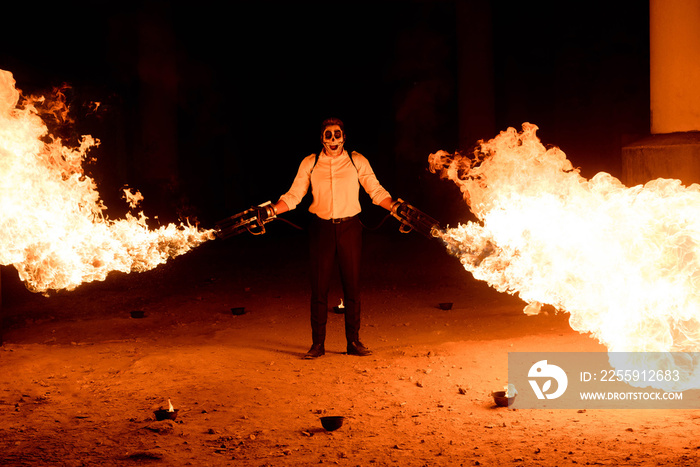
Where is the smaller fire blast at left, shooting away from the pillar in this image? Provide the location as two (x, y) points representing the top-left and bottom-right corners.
(0, 70), (214, 293)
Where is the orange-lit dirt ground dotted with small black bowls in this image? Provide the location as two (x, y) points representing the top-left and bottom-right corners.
(0, 224), (700, 466)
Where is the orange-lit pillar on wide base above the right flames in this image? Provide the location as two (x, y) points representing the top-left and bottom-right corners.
(622, 0), (700, 186)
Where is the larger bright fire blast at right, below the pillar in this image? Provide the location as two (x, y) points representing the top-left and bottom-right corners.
(430, 123), (700, 390)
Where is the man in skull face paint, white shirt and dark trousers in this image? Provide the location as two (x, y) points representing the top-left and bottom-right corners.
(270, 118), (394, 358)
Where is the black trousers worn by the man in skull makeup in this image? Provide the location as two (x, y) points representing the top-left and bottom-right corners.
(309, 216), (362, 344)
